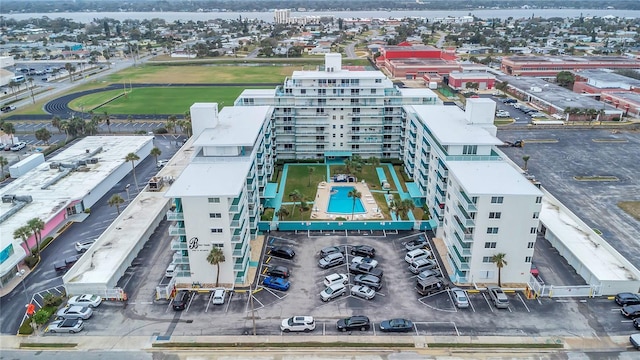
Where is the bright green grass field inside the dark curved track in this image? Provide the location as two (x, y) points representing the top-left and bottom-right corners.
(69, 86), (268, 115)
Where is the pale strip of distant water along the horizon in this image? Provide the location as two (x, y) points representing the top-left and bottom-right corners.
(5, 9), (640, 23)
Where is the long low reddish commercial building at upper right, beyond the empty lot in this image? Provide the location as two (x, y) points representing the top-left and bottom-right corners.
(500, 56), (640, 77)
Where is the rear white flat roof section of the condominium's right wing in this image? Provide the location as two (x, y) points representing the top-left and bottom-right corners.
(407, 105), (503, 145)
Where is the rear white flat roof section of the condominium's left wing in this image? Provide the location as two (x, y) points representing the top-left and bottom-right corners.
(193, 106), (271, 146)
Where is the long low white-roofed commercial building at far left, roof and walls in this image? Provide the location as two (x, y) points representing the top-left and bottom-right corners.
(0, 136), (153, 286)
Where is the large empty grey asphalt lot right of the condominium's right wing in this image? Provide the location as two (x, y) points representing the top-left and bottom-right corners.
(498, 130), (640, 265)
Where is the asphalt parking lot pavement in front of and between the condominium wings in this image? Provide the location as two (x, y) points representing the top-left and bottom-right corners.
(42, 233), (632, 338)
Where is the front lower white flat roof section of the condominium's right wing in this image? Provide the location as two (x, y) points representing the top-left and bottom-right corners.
(447, 161), (542, 196)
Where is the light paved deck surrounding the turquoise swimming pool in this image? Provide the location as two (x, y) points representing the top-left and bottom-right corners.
(311, 181), (384, 221)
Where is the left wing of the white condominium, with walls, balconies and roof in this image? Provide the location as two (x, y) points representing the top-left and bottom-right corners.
(166, 103), (273, 288)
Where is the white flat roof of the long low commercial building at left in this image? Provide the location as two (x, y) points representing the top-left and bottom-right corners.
(0, 136), (153, 252)
